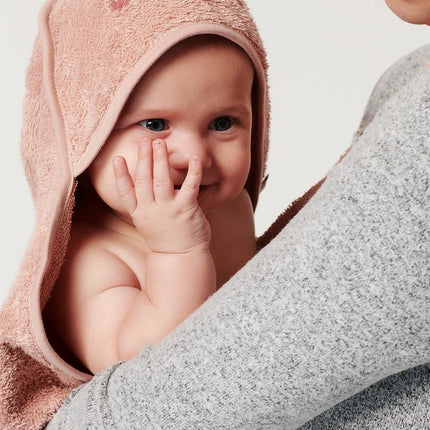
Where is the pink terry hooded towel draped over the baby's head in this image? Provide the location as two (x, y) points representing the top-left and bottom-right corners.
(0, 0), (269, 430)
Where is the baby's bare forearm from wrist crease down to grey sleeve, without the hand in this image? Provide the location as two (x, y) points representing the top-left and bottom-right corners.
(116, 251), (216, 363)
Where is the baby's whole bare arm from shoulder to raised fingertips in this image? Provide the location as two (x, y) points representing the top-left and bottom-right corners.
(54, 138), (216, 374)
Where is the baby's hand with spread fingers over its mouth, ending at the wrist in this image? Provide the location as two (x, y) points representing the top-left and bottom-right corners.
(113, 139), (211, 253)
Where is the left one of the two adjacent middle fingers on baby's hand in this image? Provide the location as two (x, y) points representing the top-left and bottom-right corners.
(134, 140), (154, 204)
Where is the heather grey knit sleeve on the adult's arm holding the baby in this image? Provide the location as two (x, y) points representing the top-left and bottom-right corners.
(46, 45), (430, 430)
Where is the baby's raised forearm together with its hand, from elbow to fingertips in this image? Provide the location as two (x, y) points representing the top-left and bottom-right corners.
(114, 140), (216, 360)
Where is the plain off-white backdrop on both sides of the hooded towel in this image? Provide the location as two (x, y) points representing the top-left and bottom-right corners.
(0, 0), (429, 303)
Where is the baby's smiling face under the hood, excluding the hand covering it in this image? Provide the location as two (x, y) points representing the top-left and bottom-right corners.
(89, 38), (254, 214)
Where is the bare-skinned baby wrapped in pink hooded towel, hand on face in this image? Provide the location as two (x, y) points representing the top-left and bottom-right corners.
(44, 35), (256, 374)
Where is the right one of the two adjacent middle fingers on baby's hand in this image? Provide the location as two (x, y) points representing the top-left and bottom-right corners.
(153, 139), (173, 203)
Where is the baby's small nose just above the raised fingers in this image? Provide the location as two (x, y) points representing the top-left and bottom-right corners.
(168, 138), (212, 170)
